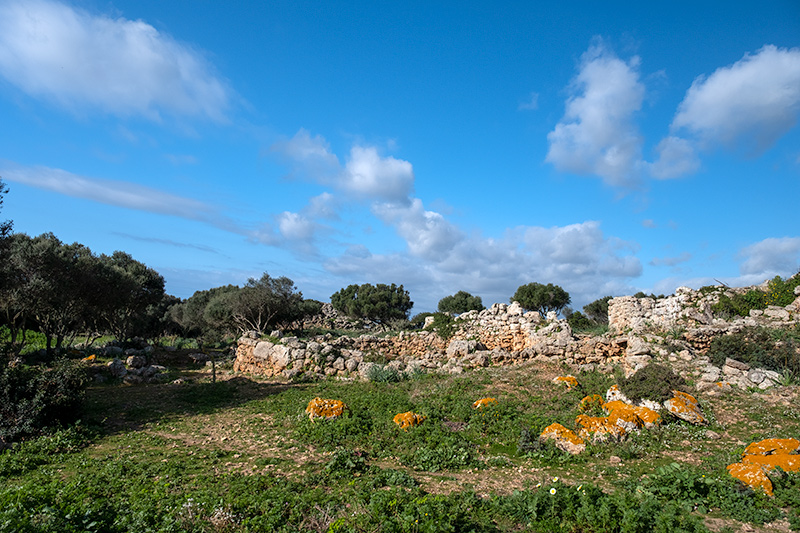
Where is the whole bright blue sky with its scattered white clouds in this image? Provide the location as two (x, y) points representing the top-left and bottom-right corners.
(0, 0), (800, 312)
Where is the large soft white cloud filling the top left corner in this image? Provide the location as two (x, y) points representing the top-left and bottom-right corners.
(0, 0), (230, 121)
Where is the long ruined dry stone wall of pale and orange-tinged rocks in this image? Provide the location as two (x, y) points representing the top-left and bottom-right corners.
(234, 280), (800, 388)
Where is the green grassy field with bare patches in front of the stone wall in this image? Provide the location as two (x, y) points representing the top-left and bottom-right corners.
(0, 354), (800, 533)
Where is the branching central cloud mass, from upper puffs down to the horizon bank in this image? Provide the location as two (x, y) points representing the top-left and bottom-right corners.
(268, 130), (642, 310)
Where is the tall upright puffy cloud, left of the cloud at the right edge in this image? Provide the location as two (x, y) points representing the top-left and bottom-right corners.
(545, 41), (645, 186)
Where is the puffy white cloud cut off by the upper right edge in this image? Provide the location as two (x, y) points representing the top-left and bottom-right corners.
(672, 45), (800, 155)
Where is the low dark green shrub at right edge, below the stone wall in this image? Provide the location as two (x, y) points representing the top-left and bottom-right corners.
(708, 327), (800, 376)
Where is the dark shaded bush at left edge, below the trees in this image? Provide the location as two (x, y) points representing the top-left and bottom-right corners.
(0, 359), (89, 441)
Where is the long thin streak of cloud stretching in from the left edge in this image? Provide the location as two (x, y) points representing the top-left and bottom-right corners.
(0, 161), (242, 233)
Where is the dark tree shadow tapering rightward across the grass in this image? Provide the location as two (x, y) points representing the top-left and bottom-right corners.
(83, 376), (305, 435)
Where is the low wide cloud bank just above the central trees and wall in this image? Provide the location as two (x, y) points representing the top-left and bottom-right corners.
(325, 221), (642, 310)
